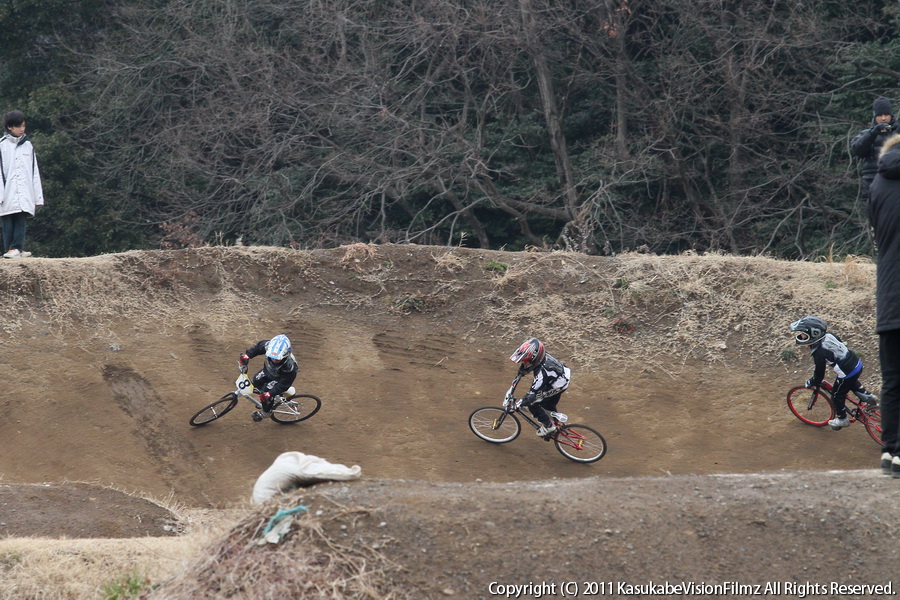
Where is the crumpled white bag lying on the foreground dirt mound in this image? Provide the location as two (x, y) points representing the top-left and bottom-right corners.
(253, 452), (362, 504)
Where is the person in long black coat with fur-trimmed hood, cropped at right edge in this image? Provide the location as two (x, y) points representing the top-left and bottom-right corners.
(868, 135), (900, 478)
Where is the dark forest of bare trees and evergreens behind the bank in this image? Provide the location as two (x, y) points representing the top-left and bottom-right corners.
(0, 0), (900, 259)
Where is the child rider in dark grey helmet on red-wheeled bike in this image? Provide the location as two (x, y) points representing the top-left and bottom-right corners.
(791, 315), (878, 429)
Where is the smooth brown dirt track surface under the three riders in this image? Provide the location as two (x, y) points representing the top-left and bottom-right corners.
(0, 246), (877, 506)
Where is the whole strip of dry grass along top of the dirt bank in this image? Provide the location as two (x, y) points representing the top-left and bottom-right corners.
(0, 244), (876, 364)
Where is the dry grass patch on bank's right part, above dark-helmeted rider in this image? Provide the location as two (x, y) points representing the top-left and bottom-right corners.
(482, 247), (877, 367)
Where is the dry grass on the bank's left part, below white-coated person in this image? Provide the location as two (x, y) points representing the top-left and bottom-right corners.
(0, 247), (312, 341)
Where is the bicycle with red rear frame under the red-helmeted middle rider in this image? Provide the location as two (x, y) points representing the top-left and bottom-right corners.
(469, 375), (606, 463)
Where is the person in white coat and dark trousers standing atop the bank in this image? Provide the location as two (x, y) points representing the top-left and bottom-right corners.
(0, 110), (44, 258)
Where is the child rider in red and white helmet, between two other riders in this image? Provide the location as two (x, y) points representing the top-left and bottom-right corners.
(509, 338), (572, 437)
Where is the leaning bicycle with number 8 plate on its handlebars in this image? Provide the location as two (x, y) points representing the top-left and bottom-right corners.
(190, 370), (322, 427)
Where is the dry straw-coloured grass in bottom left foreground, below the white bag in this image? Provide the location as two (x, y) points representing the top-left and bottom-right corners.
(0, 497), (406, 600)
